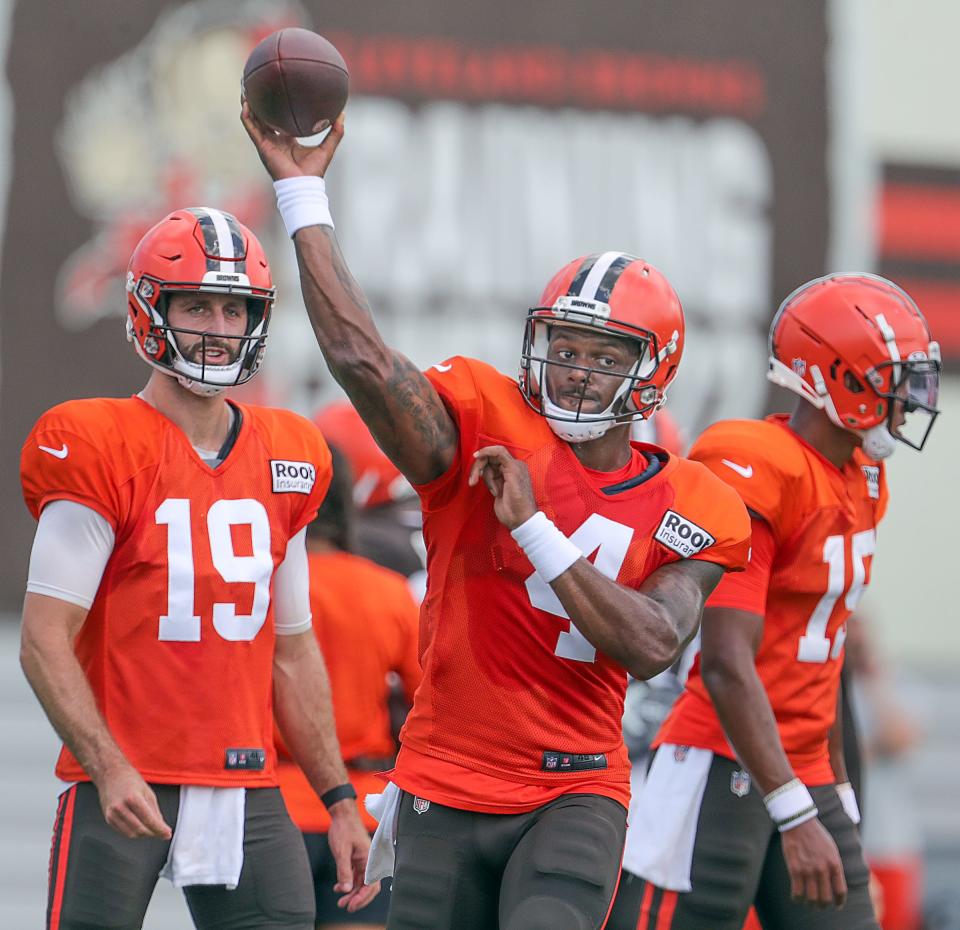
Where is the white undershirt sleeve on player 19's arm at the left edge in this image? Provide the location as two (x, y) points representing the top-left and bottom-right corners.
(27, 500), (115, 610)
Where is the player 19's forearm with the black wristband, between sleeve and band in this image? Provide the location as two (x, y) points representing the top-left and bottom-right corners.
(273, 631), (349, 795)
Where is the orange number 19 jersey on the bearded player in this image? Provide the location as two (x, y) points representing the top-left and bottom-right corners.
(21, 397), (331, 787)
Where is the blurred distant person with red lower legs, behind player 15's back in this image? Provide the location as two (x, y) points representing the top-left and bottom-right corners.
(846, 613), (923, 930)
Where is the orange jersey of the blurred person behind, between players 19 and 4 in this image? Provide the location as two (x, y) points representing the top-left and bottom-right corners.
(277, 552), (420, 833)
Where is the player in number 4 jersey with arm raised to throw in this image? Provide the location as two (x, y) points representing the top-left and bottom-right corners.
(242, 104), (749, 930)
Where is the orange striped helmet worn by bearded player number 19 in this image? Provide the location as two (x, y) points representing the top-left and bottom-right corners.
(127, 207), (276, 394)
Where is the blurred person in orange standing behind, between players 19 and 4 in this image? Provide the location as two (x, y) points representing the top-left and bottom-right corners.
(277, 445), (420, 930)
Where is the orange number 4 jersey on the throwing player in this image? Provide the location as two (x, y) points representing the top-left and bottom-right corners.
(391, 358), (750, 813)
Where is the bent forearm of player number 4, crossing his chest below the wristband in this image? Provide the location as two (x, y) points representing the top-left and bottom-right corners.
(552, 559), (684, 679)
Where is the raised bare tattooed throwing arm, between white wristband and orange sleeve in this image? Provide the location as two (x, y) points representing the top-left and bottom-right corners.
(295, 226), (457, 484)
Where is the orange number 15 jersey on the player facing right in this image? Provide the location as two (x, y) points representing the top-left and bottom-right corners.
(656, 416), (887, 785)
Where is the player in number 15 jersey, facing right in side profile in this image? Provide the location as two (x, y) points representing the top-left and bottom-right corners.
(610, 274), (940, 930)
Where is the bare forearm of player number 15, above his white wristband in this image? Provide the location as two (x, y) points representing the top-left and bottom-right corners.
(701, 652), (795, 795)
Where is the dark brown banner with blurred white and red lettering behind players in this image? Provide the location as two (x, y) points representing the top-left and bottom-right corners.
(0, 0), (829, 608)
